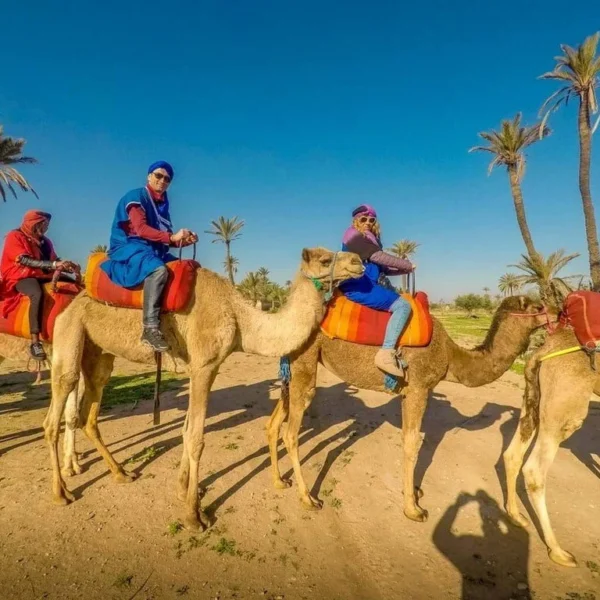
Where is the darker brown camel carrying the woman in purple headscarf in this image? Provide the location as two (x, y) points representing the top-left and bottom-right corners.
(267, 296), (545, 521)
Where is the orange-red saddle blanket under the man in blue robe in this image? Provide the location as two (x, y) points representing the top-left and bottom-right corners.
(85, 252), (200, 312)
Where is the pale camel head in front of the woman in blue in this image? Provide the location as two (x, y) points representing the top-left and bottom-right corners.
(300, 248), (365, 293)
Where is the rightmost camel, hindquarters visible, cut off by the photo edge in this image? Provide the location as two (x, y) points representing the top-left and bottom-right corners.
(504, 329), (600, 567)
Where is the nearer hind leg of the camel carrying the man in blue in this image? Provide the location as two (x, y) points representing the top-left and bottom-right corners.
(44, 342), (83, 506)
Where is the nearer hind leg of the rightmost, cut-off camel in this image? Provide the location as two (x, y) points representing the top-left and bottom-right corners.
(523, 410), (589, 567)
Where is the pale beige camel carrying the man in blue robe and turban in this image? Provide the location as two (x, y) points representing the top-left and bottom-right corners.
(44, 248), (364, 528)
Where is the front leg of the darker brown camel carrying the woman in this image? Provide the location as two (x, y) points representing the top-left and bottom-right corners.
(402, 384), (429, 522)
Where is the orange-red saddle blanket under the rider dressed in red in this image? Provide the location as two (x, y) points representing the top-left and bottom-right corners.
(0, 281), (81, 342)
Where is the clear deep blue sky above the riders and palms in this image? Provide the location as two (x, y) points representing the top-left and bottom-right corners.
(0, 0), (600, 300)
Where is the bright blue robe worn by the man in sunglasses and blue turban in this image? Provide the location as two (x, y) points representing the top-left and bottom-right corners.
(101, 188), (176, 288)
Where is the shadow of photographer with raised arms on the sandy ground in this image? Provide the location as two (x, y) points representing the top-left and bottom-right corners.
(432, 490), (531, 600)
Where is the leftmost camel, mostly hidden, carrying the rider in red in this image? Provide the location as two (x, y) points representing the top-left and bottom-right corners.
(0, 333), (83, 477)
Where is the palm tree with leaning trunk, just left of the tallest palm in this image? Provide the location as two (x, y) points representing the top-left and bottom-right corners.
(469, 113), (550, 258)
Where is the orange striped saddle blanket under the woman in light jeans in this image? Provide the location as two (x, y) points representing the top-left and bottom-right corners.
(321, 292), (433, 347)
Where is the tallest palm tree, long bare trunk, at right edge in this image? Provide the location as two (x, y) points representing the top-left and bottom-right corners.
(540, 32), (600, 292)
